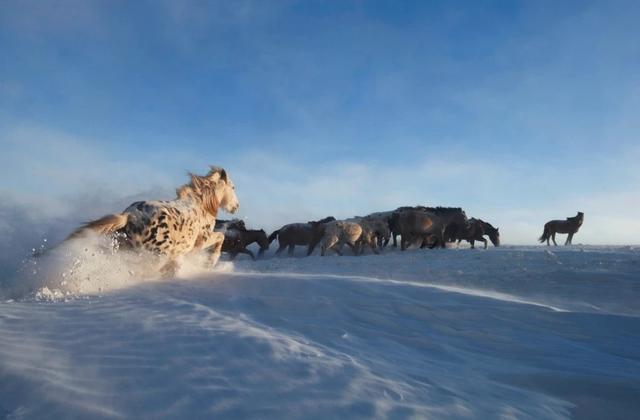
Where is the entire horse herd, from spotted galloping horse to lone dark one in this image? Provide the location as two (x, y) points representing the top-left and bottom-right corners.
(67, 166), (584, 275)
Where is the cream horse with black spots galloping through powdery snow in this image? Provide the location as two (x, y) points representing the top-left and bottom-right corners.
(67, 166), (240, 276)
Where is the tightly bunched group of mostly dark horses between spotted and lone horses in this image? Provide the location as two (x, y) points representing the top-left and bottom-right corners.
(216, 206), (500, 259)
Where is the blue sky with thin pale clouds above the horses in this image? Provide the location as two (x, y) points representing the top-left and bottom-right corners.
(0, 1), (640, 244)
